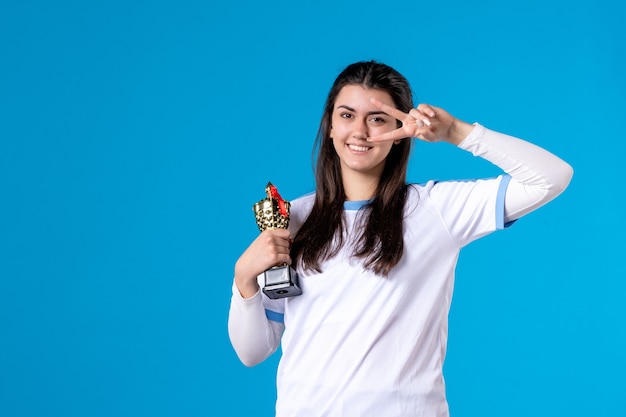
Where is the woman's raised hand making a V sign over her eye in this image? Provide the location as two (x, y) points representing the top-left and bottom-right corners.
(368, 98), (473, 145)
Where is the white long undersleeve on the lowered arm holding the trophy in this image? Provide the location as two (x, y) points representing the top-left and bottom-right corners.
(228, 285), (283, 366)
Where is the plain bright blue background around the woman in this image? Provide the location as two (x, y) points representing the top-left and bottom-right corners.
(0, 0), (626, 417)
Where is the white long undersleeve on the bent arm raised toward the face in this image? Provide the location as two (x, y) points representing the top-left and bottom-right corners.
(458, 124), (573, 221)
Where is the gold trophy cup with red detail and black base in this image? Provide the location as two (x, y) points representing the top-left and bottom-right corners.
(252, 182), (302, 299)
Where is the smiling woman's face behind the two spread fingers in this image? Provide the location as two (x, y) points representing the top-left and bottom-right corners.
(330, 84), (397, 178)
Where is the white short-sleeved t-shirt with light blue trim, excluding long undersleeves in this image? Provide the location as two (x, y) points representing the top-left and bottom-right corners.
(263, 175), (510, 417)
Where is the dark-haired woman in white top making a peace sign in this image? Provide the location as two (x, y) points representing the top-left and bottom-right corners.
(229, 61), (573, 417)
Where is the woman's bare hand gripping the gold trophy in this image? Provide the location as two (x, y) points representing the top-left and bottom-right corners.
(235, 229), (291, 298)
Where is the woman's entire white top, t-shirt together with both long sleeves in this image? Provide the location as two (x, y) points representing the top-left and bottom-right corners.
(228, 124), (573, 417)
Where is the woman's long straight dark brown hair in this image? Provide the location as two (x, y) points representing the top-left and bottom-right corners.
(291, 61), (413, 276)
